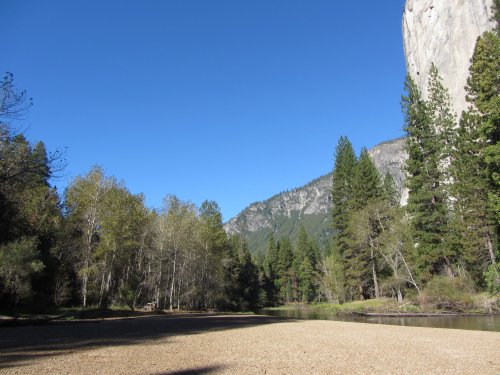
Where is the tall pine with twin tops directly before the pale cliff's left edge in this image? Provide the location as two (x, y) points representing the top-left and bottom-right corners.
(402, 68), (455, 281)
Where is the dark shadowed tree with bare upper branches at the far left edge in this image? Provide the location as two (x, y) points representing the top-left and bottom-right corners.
(0, 73), (61, 307)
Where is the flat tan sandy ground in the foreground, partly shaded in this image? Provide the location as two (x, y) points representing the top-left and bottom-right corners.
(0, 314), (500, 375)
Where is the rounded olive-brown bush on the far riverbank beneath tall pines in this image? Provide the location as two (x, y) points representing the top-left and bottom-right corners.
(418, 276), (474, 311)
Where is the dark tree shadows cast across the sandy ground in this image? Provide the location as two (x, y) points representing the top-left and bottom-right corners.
(0, 314), (293, 375)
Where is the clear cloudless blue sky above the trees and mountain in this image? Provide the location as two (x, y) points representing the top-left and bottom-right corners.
(0, 0), (405, 220)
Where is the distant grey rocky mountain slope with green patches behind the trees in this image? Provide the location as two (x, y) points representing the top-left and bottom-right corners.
(224, 138), (407, 252)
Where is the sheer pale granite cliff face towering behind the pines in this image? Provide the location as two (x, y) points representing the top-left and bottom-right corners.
(403, 0), (494, 115)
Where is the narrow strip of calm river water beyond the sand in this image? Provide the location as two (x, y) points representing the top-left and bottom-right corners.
(258, 309), (500, 332)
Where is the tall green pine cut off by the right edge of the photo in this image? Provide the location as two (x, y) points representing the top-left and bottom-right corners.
(451, 16), (500, 289)
